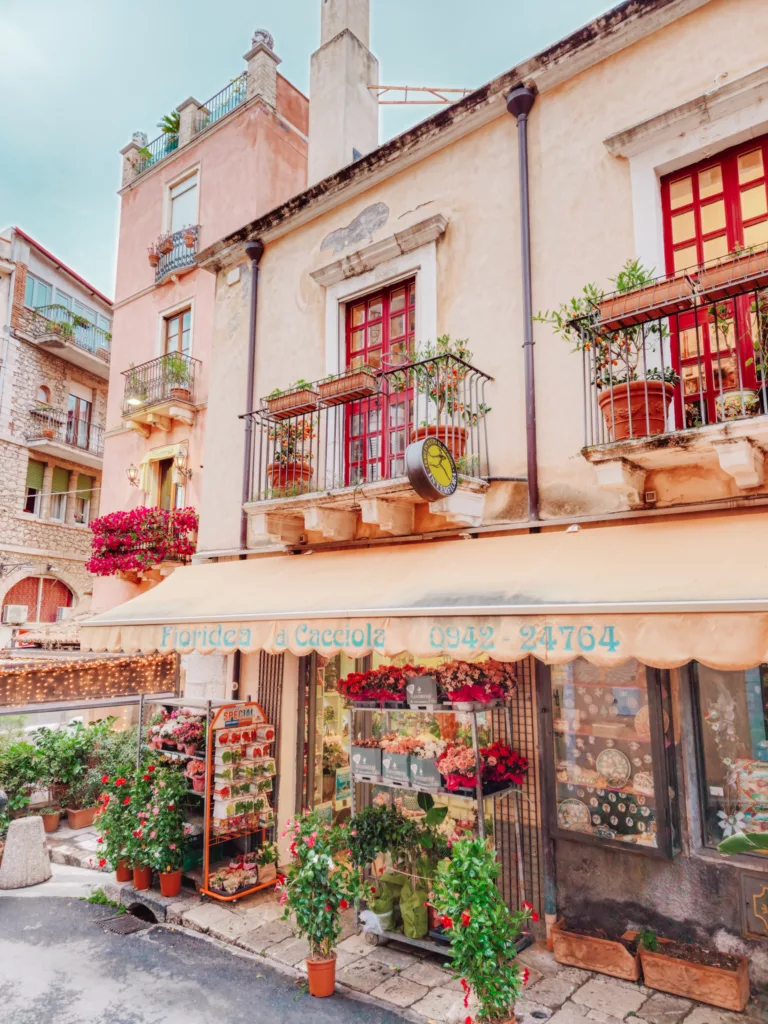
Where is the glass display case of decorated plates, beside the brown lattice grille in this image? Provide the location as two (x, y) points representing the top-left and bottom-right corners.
(541, 658), (679, 858)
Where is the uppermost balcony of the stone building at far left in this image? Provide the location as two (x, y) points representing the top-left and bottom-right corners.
(16, 305), (112, 380)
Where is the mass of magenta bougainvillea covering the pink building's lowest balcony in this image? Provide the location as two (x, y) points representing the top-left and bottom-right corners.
(85, 507), (198, 575)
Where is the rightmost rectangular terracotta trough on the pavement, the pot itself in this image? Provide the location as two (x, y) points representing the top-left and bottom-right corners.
(640, 939), (750, 1013)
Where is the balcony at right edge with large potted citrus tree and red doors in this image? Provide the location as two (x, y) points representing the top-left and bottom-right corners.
(571, 250), (768, 507)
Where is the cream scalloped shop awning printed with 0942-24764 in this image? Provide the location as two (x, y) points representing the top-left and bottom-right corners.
(81, 512), (768, 670)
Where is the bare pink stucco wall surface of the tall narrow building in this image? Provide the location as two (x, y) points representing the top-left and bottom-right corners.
(93, 88), (308, 609)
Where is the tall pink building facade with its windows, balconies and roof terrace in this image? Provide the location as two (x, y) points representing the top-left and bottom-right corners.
(95, 32), (307, 626)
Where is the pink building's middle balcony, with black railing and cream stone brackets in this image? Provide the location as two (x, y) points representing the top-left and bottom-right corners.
(123, 352), (202, 437)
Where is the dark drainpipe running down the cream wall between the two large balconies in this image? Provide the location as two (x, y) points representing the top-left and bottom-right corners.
(507, 85), (539, 522)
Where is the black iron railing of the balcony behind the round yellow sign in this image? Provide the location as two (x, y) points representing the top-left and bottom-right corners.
(244, 355), (493, 501)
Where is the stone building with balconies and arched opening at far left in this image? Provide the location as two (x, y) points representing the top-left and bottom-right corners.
(0, 227), (112, 644)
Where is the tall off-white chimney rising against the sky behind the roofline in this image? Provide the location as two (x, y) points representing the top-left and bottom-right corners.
(309, 0), (379, 185)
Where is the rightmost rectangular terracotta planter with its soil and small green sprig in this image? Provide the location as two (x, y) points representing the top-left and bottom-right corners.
(638, 929), (750, 1013)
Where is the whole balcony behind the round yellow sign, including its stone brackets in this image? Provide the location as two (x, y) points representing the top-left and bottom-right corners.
(245, 355), (492, 547)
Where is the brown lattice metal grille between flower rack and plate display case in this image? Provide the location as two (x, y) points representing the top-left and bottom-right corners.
(486, 660), (544, 914)
